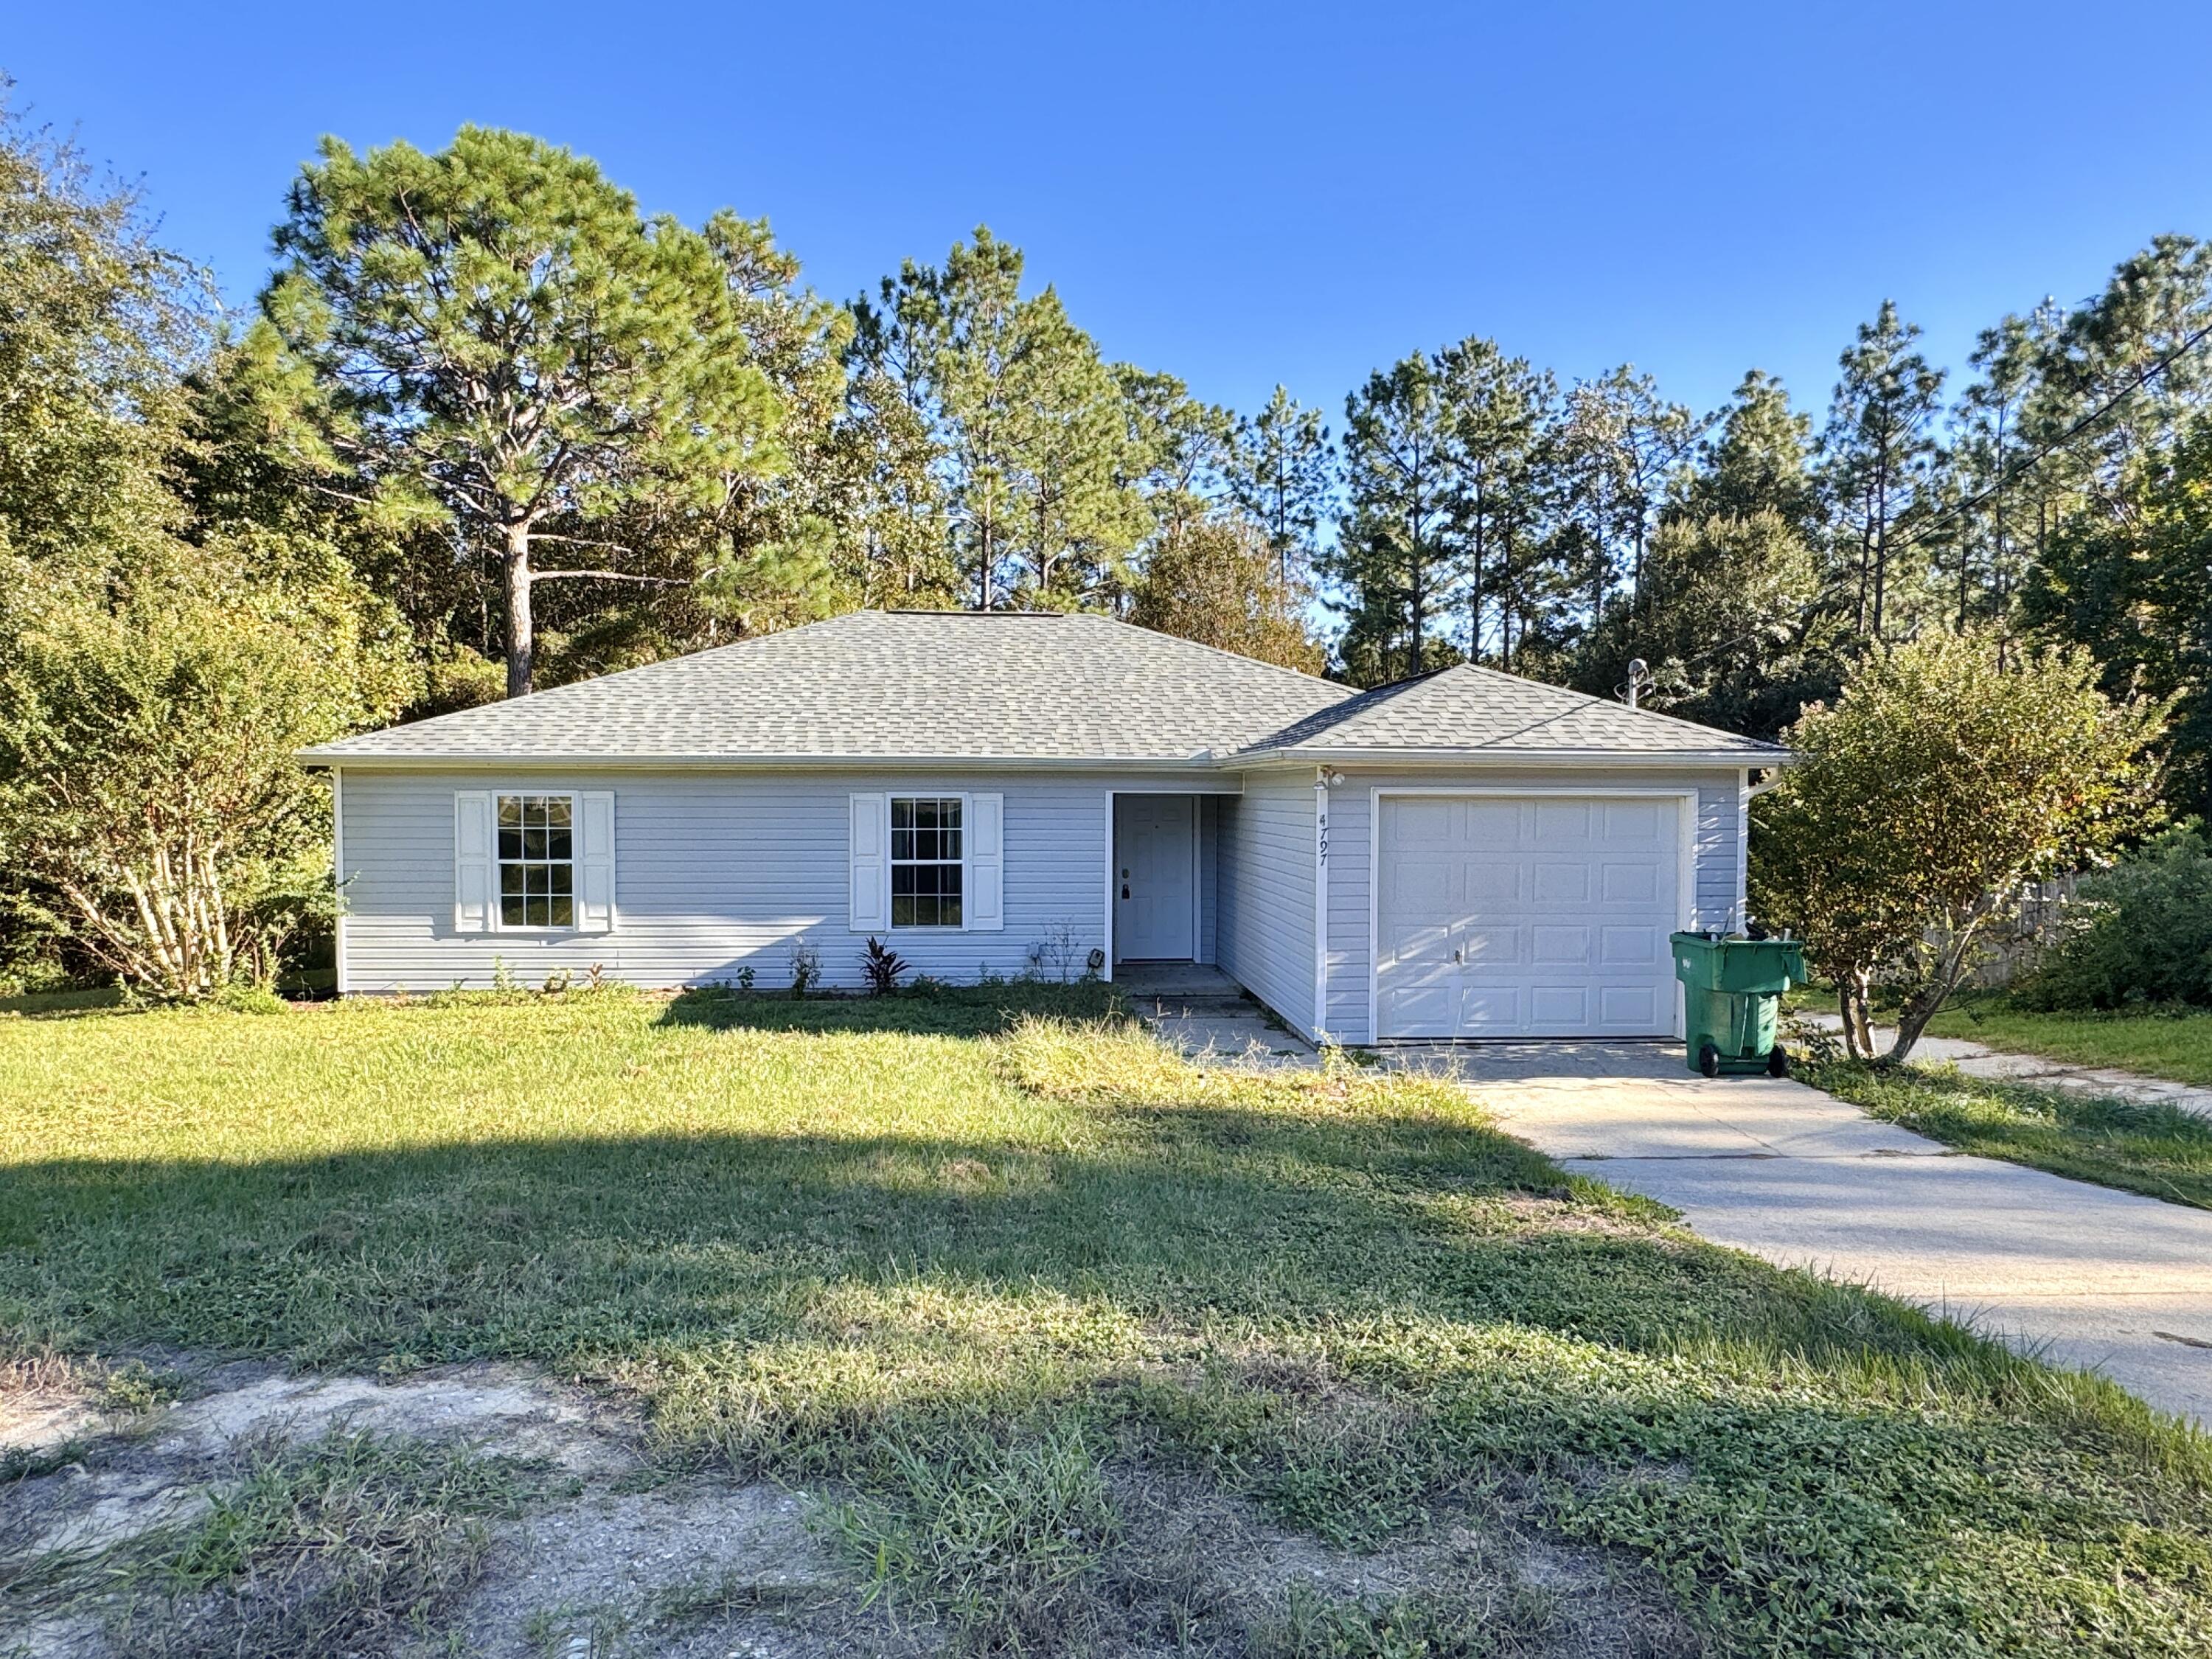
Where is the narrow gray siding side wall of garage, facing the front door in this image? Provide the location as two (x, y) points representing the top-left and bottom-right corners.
(1214, 768), (1314, 1035)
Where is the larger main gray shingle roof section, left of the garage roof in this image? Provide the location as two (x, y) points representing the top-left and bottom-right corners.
(303, 611), (1352, 765)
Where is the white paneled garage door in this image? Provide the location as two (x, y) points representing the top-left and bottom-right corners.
(1376, 794), (1683, 1037)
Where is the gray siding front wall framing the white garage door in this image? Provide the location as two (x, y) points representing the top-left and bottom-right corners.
(1318, 765), (1745, 1044)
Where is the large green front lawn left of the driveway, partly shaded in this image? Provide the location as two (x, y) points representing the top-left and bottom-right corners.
(0, 987), (2212, 1657)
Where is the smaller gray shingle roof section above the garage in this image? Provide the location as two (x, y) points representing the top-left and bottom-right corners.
(1252, 664), (1787, 765)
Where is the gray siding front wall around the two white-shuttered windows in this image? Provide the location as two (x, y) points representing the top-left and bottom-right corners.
(338, 768), (1230, 991)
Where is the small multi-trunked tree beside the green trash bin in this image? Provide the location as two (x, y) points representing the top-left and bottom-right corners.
(1752, 635), (2166, 1062)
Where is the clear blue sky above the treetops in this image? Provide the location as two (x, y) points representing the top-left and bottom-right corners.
(13, 0), (2212, 420)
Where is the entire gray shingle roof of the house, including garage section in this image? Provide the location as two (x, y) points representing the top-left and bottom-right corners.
(303, 611), (1778, 765)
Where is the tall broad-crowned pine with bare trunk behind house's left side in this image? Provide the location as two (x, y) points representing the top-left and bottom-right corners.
(261, 126), (781, 697)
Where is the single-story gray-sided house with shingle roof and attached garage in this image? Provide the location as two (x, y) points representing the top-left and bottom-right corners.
(301, 611), (1783, 1044)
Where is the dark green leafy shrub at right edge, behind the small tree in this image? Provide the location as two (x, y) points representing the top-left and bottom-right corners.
(2013, 823), (2212, 1009)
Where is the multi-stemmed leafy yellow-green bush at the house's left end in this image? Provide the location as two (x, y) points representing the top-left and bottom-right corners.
(0, 555), (407, 998)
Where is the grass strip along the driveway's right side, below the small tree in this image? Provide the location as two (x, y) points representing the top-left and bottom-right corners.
(1801, 1062), (2212, 1210)
